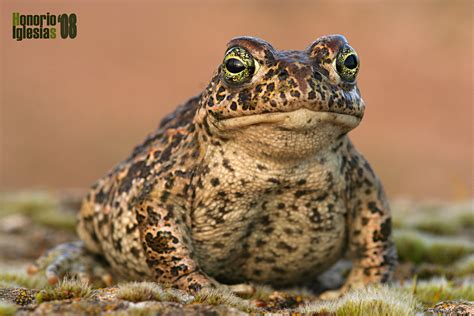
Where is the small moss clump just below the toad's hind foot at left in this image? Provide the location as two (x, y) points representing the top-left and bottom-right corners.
(36, 279), (92, 303)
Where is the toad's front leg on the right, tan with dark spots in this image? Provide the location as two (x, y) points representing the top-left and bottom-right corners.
(344, 149), (397, 289)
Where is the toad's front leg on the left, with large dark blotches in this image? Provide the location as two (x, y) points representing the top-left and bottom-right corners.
(135, 200), (216, 292)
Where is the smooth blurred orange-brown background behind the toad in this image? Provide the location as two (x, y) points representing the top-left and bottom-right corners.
(0, 0), (474, 199)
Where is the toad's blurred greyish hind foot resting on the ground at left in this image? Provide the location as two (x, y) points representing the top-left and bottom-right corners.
(28, 241), (112, 286)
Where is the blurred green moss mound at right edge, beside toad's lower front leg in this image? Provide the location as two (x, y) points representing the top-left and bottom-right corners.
(394, 230), (474, 265)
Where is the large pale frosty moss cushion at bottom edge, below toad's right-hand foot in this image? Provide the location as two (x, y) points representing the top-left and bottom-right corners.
(295, 286), (420, 316)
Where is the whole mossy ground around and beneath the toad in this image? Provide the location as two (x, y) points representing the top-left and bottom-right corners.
(0, 193), (474, 316)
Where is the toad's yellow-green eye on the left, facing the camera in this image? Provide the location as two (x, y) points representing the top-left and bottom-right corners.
(222, 46), (258, 84)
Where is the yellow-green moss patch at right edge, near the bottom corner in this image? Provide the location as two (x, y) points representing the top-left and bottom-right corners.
(404, 278), (474, 306)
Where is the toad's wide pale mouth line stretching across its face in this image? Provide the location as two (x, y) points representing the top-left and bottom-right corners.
(215, 108), (361, 130)
